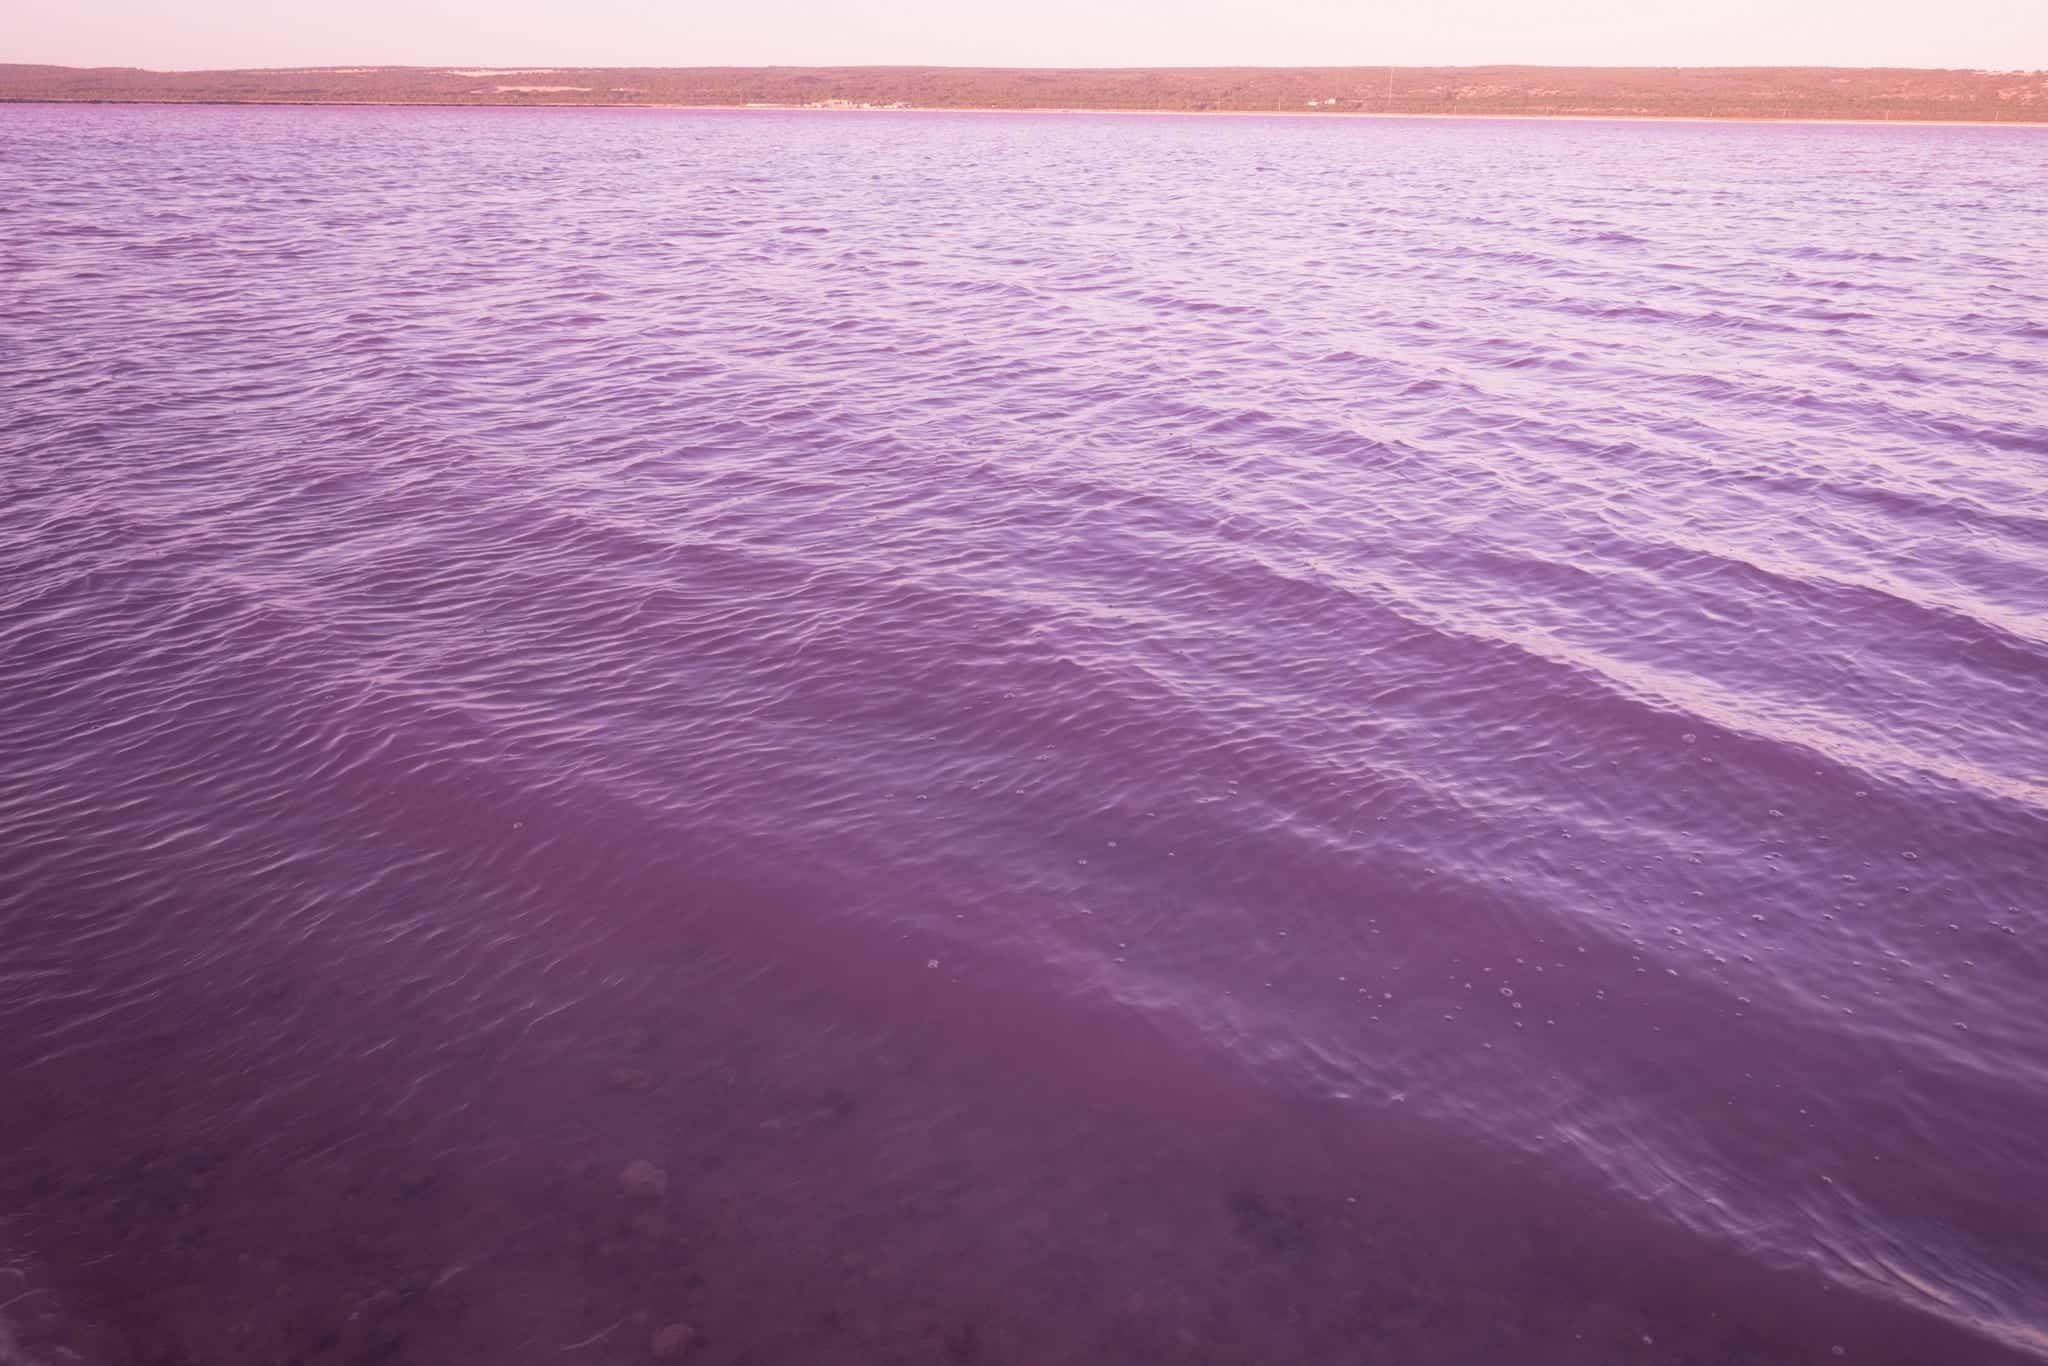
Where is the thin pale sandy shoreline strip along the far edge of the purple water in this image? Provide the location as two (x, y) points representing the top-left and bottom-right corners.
(0, 94), (2048, 129)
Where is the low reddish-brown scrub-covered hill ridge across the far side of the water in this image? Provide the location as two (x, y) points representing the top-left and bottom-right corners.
(0, 63), (2048, 123)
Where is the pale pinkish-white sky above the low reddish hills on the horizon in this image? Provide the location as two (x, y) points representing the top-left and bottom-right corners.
(12, 0), (2048, 70)
